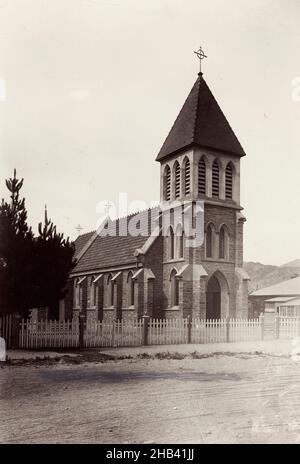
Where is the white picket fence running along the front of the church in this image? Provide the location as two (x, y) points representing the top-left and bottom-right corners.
(19, 319), (262, 349)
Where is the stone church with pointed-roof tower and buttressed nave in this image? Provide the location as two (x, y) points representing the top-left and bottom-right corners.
(60, 72), (249, 321)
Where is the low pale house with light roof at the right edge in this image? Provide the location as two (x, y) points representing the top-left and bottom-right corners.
(249, 277), (300, 318)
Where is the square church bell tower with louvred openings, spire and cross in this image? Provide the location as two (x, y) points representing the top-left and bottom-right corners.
(156, 48), (249, 319)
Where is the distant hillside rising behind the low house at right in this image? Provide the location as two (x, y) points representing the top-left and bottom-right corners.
(244, 259), (300, 291)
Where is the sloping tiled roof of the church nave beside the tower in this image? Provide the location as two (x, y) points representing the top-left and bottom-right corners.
(72, 208), (157, 275)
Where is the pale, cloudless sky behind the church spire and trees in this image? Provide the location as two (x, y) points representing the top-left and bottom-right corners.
(0, 0), (300, 265)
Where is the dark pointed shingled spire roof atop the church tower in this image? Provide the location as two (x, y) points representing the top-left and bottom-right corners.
(156, 73), (245, 161)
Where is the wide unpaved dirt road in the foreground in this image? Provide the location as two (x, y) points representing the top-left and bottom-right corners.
(0, 354), (300, 444)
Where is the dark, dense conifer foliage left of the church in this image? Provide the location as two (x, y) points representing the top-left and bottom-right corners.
(0, 170), (75, 317)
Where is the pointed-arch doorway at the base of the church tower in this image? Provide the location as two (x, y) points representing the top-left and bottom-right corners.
(206, 271), (229, 319)
